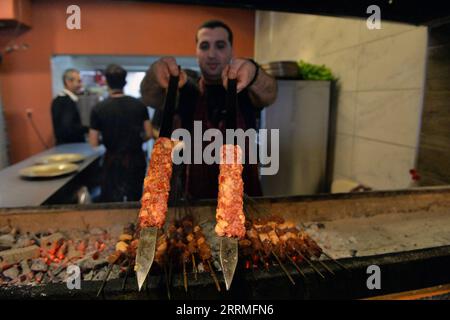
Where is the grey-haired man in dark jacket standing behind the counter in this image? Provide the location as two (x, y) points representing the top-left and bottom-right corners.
(51, 69), (88, 144)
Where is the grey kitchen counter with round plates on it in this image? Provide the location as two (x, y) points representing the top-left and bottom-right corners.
(0, 143), (104, 208)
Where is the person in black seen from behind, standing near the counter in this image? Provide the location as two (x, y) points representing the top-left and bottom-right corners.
(89, 65), (152, 202)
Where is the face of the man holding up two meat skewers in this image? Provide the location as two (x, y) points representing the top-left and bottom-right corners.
(197, 27), (233, 81)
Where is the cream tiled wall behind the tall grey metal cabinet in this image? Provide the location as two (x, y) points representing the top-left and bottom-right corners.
(255, 11), (427, 189)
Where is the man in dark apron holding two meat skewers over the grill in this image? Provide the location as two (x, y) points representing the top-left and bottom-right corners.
(141, 21), (277, 198)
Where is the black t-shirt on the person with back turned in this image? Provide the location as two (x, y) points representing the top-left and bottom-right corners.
(91, 96), (149, 153)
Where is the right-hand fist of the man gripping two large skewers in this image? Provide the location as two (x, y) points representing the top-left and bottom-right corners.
(222, 59), (256, 92)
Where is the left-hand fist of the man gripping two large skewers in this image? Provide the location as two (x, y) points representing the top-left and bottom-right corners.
(150, 57), (187, 89)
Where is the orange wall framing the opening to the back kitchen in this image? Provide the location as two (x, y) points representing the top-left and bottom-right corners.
(0, 0), (255, 163)
